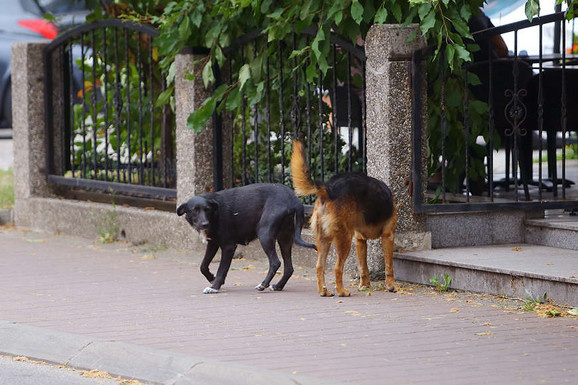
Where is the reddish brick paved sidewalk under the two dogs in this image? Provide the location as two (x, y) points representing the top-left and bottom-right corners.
(0, 225), (578, 385)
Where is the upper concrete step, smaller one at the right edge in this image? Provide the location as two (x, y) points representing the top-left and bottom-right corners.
(525, 214), (578, 250)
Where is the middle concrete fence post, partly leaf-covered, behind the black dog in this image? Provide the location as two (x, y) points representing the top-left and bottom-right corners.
(175, 49), (214, 205)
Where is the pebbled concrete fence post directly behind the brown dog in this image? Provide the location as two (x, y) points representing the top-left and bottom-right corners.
(365, 25), (431, 254)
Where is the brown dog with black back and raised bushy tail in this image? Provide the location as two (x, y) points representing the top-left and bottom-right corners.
(291, 141), (397, 297)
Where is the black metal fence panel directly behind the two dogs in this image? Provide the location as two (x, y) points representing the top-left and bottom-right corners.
(216, 29), (366, 194)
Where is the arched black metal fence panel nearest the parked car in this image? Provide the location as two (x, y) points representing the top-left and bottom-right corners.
(44, 20), (176, 200)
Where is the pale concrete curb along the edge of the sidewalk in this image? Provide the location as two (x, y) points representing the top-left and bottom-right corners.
(0, 321), (340, 385)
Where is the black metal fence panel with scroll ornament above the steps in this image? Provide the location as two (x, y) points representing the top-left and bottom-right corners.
(413, 12), (578, 212)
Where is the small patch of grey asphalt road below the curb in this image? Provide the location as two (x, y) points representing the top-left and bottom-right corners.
(0, 356), (132, 385)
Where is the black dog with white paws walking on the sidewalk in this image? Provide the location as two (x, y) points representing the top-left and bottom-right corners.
(177, 183), (315, 294)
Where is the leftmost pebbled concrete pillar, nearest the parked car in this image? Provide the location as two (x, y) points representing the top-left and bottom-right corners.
(12, 42), (50, 226)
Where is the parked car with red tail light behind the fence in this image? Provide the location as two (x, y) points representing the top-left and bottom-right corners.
(0, 0), (88, 128)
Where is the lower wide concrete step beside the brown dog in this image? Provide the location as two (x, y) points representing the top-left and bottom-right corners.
(394, 244), (578, 307)
